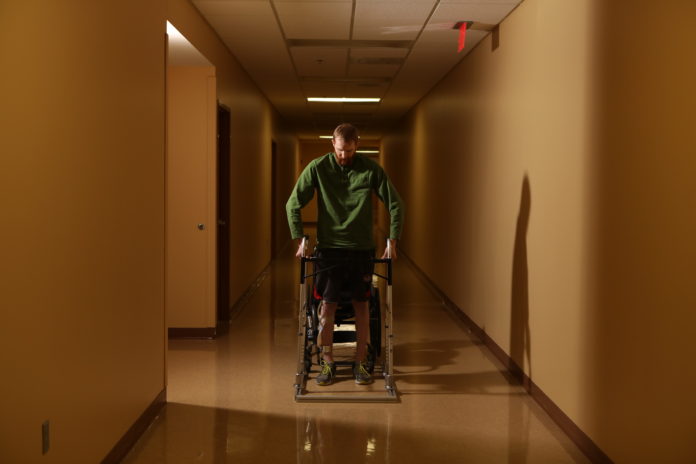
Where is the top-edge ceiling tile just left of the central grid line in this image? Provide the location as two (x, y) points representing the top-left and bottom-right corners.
(274, 1), (353, 40)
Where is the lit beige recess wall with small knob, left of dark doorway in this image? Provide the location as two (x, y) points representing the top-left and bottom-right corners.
(164, 66), (217, 328)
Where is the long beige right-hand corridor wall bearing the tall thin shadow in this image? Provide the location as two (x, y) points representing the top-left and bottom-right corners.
(383, 0), (696, 463)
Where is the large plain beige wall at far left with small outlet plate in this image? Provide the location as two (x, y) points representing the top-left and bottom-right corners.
(0, 0), (165, 463)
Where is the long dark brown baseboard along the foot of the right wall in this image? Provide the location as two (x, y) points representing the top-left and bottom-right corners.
(399, 250), (613, 464)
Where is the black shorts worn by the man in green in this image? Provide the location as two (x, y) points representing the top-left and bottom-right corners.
(314, 248), (375, 303)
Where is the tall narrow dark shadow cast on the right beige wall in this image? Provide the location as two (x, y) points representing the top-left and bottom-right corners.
(510, 174), (532, 379)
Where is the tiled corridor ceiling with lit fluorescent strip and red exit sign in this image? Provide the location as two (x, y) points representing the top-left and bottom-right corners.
(185, 0), (522, 138)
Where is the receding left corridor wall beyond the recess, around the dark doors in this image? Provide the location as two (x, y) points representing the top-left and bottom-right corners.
(167, 0), (297, 308)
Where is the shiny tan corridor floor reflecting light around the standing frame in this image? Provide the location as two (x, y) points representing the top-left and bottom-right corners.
(123, 243), (589, 464)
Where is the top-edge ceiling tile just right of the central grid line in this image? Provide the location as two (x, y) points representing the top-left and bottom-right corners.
(353, 0), (435, 40)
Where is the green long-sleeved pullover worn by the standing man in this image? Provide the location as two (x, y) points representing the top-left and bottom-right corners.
(285, 153), (404, 250)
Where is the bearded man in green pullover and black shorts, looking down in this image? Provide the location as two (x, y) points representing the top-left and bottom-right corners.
(286, 124), (404, 386)
